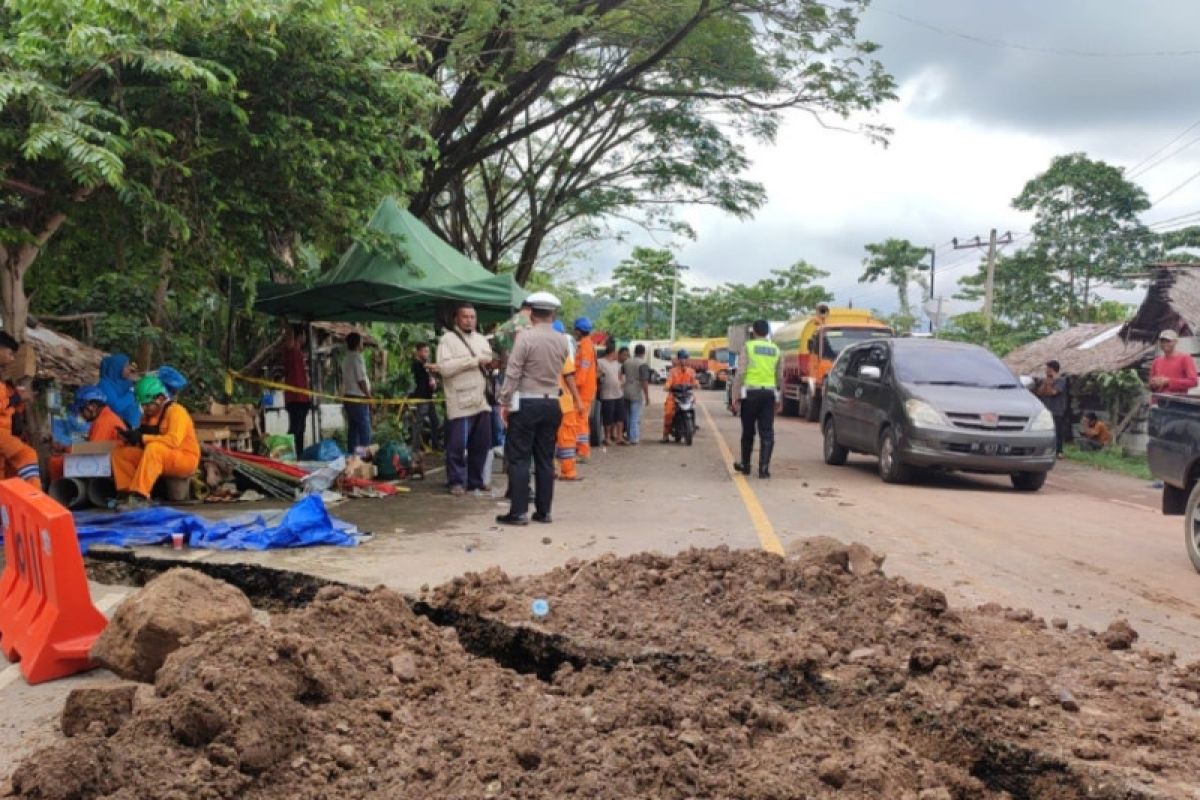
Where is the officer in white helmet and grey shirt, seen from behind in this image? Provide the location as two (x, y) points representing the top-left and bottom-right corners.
(496, 291), (575, 525)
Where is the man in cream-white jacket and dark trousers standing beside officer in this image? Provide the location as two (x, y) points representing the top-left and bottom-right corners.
(432, 303), (494, 497)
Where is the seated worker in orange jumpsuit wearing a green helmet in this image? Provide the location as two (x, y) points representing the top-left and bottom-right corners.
(113, 374), (200, 509)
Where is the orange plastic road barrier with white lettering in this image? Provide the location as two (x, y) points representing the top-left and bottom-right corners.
(0, 479), (108, 684)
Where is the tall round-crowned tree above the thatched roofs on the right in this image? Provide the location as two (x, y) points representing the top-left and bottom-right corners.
(1013, 152), (1157, 323)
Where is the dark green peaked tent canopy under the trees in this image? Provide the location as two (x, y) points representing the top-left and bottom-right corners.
(254, 198), (526, 323)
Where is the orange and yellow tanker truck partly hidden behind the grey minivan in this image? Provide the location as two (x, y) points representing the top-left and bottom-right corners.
(772, 306), (894, 422)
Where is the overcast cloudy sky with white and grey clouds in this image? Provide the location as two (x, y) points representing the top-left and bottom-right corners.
(581, 0), (1200, 319)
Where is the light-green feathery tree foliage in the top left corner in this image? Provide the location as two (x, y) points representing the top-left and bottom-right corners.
(0, 0), (233, 338)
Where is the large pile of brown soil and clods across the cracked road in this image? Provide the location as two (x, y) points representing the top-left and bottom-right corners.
(11, 542), (1200, 800)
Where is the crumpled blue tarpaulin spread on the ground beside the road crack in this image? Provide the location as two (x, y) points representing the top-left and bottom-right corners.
(74, 494), (359, 553)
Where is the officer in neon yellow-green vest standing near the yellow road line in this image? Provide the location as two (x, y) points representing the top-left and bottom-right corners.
(733, 319), (784, 477)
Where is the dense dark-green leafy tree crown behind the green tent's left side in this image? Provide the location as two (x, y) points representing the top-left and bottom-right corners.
(15, 0), (433, 367)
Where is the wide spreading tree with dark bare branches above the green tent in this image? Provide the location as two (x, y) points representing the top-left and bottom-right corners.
(408, 0), (894, 279)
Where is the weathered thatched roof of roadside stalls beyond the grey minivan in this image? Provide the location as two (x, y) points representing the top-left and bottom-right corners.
(1004, 261), (1200, 375)
